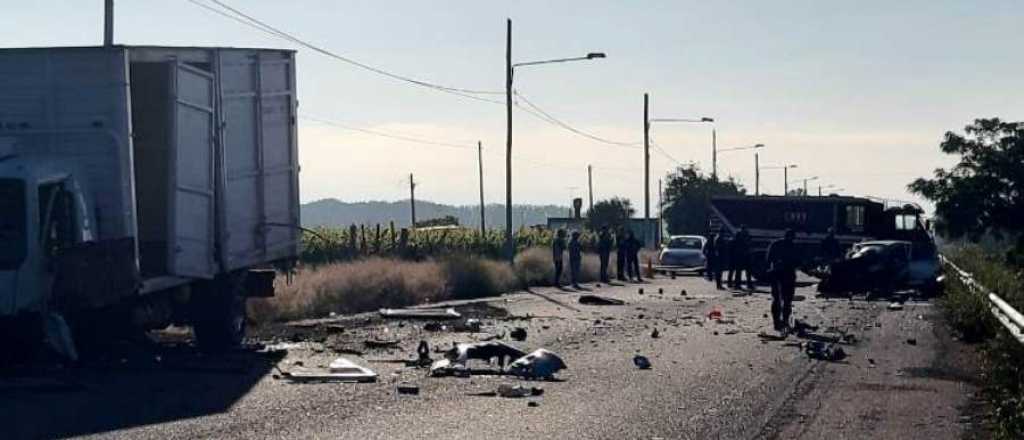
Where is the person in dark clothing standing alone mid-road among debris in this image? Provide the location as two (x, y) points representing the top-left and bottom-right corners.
(767, 229), (799, 333)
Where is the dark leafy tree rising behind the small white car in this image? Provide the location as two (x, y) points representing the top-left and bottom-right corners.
(664, 164), (746, 234)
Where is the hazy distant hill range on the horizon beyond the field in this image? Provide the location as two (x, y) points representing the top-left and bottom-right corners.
(302, 199), (570, 228)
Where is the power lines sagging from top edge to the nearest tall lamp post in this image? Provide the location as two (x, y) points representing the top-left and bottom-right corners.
(187, 0), (503, 99)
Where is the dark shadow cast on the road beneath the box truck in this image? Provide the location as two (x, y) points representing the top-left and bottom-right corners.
(0, 344), (286, 439)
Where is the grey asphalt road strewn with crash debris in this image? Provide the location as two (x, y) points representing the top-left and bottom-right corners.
(0, 277), (976, 440)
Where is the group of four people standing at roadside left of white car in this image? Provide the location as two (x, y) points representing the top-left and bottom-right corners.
(551, 226), (643, 289)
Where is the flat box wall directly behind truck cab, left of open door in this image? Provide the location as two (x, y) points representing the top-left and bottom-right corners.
(0, 47), (135, 239)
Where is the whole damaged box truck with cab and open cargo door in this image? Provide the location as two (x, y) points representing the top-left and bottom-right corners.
(0, 46), (301, 349)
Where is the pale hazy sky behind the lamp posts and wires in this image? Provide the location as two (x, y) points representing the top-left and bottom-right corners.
(0, 0), (1024, 212)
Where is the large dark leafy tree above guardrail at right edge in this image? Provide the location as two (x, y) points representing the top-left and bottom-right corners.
(908, 118), (1024, 244)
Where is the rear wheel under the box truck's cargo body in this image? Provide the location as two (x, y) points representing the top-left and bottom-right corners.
(190, 271), (248, 352)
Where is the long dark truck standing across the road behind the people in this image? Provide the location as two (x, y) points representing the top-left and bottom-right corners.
(708, 195), (934, 278)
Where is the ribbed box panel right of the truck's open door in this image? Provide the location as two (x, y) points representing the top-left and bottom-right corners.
(218, 49), (301, 270)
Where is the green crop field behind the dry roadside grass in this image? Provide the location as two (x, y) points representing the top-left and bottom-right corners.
(302, 223), (597, 265)
